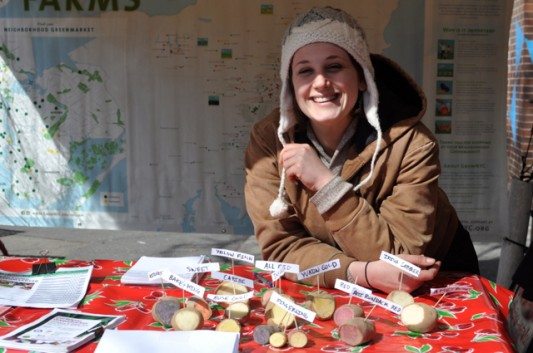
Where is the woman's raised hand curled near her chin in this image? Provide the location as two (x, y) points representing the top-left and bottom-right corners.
(279, 143), (334, 191)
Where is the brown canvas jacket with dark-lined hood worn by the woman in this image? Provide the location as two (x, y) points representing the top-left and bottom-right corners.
(245, 55), (458, 287)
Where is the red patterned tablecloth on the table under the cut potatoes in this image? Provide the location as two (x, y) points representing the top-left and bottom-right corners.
(0, 257), (513, 353)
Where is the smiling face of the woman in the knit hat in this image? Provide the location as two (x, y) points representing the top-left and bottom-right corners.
(291, 43), (366, 126)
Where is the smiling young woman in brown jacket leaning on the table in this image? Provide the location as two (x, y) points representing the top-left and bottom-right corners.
(245, 7), (479, 292)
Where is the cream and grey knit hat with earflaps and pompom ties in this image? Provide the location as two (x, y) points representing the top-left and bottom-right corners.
(270, 7), (381, 218)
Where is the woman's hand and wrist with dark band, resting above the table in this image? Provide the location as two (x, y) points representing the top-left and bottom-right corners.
(348, 254), (440, 293)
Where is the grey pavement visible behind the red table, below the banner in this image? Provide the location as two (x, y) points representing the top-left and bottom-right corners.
(0, 226), (501, 281)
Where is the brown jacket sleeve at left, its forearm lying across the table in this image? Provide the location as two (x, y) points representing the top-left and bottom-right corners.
(245, 118), (354, 287)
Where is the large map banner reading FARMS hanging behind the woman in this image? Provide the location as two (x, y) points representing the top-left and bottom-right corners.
(0, 0), (503, 241)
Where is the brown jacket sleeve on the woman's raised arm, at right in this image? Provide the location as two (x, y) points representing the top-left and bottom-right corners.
(322, 128), (441, 261)
